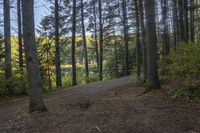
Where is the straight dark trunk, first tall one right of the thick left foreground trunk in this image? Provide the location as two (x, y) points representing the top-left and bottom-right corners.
(55, 0), (62, 88)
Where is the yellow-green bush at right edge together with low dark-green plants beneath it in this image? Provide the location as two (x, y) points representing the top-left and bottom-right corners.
(163, 43), (200, 101)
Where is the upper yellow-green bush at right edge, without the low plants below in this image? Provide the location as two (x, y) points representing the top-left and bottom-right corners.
(165, 44), (200, 84)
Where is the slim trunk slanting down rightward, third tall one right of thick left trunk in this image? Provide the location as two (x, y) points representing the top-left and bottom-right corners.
(81, 0), (89, 77)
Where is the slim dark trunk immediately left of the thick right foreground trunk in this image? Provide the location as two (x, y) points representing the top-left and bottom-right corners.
(139, 0), (147, 81)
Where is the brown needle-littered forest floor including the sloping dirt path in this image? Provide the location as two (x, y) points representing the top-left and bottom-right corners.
(0, 77), (200, 133)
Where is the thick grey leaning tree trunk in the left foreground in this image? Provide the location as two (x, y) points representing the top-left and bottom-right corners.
(22, 0), (47, 112)
